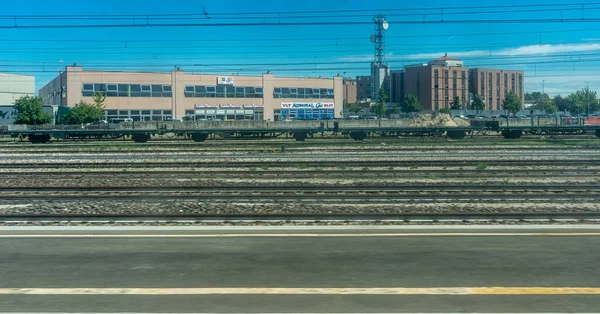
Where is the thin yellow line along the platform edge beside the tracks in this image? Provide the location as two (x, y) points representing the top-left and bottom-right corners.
(0, 232), (600, 238)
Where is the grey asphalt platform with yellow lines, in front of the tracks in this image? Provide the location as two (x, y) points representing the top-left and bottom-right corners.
(0, 226), (600, 313)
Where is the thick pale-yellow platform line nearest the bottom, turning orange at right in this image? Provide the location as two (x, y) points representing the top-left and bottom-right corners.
(0, 287), (600, 295)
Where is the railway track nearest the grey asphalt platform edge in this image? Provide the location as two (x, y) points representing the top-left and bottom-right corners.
(0, 212), (600, 223)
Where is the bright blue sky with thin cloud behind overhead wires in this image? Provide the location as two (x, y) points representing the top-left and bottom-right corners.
(0, 0), (600, 95)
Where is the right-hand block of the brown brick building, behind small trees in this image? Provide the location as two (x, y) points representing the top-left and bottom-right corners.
(469, 68), (525, 110)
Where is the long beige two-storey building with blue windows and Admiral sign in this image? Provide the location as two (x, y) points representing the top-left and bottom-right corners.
(39, 65), (344, 121)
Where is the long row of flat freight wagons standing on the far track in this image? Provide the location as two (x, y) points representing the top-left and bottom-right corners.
(7, 117), (600, 143)
